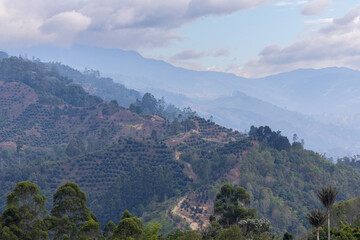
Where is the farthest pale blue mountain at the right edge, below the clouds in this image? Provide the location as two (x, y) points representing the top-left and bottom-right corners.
(242, 68), (360, 114)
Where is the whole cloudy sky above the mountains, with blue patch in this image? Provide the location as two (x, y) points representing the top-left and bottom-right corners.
(0, 0), (360, 77)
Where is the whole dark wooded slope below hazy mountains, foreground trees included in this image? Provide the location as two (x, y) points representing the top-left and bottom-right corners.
(0, 56), (360, 239)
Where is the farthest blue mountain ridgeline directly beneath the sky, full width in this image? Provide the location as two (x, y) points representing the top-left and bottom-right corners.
(14, 46), (360, 114)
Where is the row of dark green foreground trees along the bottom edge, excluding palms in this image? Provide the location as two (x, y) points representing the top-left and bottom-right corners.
(0, 181), (280, 240)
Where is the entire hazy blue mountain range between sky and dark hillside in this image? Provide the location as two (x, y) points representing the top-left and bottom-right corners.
(11, 46), (360, 157)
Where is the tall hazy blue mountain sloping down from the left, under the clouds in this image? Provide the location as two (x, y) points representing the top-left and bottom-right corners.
(12, 46), (245, 96)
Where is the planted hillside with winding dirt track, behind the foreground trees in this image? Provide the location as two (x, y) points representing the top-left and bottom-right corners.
(0, 55), (360, 234)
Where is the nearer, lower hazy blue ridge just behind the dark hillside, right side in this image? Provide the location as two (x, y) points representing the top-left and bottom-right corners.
(150, 91), (360, 158)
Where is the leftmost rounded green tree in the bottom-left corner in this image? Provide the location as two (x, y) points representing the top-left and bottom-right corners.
(1, 181), (48, 239)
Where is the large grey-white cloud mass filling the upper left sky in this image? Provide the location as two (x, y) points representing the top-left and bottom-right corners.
(0, 0), (266, 49)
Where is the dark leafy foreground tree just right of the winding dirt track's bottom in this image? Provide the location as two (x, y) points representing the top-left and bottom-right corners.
(210, 184), (255, 226)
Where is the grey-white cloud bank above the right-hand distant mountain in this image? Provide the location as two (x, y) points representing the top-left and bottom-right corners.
(233, 6), (360, 77)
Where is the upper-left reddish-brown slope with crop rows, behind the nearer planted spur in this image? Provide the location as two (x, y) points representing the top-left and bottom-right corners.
(0, 58), (168, 154)
